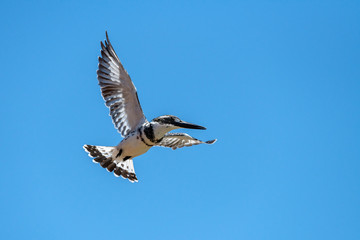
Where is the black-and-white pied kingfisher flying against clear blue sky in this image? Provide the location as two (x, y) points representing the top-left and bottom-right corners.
(83, 31), (217, 182)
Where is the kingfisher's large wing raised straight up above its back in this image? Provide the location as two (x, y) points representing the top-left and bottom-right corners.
(97, 32), (146, 137)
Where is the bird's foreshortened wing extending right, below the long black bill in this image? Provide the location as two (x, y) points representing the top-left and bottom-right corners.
(156, 133), (216, 150)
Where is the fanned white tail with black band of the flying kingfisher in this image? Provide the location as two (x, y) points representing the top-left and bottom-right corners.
(84, 145), (138, 182)
